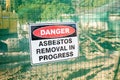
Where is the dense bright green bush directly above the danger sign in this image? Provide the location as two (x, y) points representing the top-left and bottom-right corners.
(16, 0), (75, 22)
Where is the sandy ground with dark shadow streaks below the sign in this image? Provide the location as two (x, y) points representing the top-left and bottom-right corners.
(0, 52), (120, 80)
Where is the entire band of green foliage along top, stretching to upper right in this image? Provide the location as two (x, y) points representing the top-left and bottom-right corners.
(3, 0), (113, 22)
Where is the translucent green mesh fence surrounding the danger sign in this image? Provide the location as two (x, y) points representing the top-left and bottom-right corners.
(0, 0), (120, 80)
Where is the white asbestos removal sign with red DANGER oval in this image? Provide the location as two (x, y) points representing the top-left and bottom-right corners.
(30, 23), (78, 64)
